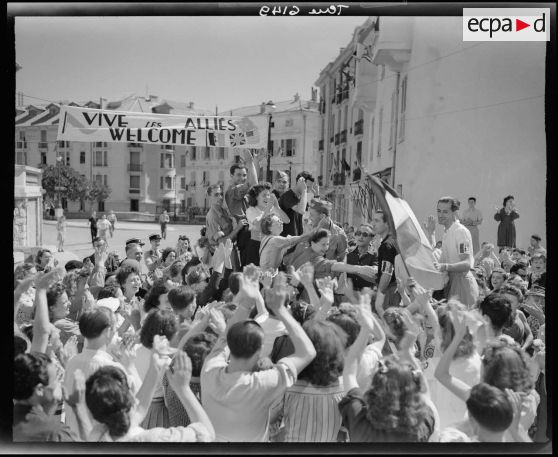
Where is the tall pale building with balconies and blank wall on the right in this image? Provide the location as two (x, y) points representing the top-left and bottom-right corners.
(316, 17), (546, 247)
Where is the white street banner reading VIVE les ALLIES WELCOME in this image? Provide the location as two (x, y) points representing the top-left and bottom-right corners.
(57, 106), (268, 149)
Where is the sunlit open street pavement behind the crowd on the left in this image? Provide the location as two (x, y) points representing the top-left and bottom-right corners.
(20, 219), (208, 265)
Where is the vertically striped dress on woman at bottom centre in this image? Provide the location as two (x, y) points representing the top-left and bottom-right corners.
(283, 378), (345, 443)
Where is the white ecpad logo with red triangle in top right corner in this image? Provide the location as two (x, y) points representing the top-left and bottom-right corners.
(463, 8), (550, 41)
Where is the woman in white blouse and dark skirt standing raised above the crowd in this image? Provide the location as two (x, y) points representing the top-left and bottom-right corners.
(246, 183), (290, 265)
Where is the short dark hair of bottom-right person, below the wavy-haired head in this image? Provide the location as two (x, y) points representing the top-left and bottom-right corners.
(466, 382), (513, 432)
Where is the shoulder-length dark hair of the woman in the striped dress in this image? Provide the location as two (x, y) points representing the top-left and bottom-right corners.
(298, 319), (347, 386)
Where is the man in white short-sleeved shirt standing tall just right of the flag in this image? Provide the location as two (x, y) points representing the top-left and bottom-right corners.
(435, 197), (479, 308)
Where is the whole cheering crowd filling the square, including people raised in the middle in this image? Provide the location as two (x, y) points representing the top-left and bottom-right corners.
(13, 151), (550, 443)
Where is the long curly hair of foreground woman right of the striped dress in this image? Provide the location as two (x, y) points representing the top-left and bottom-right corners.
(364, 356), (432, 441)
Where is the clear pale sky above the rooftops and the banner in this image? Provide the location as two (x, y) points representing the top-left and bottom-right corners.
(15, 16), (366, 111)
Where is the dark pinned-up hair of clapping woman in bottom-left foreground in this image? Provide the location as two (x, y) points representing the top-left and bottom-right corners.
(85, 366), (134, 438)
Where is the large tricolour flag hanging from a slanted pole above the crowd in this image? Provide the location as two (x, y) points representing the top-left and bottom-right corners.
(368, 176), (444, 290)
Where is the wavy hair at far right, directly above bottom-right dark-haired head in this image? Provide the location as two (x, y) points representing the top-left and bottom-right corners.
(482, 340), (533, 393)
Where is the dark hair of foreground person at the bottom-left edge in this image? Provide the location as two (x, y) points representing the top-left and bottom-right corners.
(14, 352), (51, 400)
